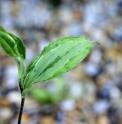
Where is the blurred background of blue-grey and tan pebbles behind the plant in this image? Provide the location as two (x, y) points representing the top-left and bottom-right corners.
(0, 0), (122, 124)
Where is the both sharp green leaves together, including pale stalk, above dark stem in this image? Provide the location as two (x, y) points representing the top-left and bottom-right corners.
(0, 27), (94, 97)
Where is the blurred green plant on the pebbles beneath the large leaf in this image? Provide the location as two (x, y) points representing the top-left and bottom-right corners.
(30, 76), (67, 104)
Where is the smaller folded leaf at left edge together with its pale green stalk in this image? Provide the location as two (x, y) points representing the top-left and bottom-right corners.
(0, 27), (26, 78)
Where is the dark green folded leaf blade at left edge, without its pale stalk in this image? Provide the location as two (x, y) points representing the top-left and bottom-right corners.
(0, 27), (25, 59)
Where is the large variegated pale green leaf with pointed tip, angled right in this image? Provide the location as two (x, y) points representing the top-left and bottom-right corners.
(22, 36), (94, 95)
